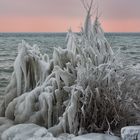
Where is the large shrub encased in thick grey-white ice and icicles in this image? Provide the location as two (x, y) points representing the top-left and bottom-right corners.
(0, 0), (140, 140)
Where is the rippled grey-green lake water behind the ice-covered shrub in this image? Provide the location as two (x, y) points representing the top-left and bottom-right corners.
(0, 33), (140, 94)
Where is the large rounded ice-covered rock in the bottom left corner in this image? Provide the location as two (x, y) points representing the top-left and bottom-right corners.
(1, 124), (53, 140)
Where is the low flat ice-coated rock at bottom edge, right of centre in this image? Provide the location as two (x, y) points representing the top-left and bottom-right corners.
(72, 133), (120, 140)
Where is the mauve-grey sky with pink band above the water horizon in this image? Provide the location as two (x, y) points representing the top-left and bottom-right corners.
(0, 0), (140, 32)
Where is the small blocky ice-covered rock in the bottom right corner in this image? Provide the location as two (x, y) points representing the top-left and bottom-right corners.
(121, 126), (140, 140)
